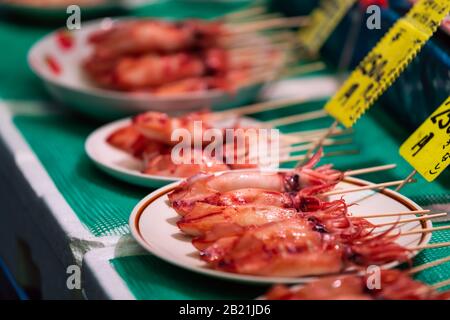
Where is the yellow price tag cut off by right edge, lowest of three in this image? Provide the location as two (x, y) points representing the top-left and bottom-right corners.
(400, 97), (450, 182)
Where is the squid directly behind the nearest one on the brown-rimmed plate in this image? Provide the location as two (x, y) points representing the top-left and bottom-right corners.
(188, 199), (374, 250)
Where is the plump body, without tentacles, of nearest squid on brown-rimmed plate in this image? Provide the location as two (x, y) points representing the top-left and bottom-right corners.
(202, 219), (344, 277)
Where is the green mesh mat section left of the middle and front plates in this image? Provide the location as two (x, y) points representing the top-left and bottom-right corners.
(14, 115), (149, 236)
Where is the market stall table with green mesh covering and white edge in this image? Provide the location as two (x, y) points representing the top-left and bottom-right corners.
(0, 0), (450, 299)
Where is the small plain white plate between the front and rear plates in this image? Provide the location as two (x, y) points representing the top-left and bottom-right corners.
(85, 118), (284, 188)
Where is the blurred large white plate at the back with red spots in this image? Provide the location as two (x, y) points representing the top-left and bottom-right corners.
(28, 18), (278, 120)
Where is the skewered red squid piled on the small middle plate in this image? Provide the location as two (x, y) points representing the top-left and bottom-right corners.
(107, 111), (298, 177)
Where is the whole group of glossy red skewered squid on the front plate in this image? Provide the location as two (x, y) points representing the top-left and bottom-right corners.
(168, 153), (410, 277)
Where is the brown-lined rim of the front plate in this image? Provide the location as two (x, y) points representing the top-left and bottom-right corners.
(129, 175), (432, 285)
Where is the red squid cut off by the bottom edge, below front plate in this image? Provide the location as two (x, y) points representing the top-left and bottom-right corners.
(264, 270), (450, 300)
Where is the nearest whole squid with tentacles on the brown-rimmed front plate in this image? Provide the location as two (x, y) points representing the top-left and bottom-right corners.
(201, 218), (409, 277)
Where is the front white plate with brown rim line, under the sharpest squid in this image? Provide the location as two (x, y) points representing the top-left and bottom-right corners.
(129, 173), (432, 284)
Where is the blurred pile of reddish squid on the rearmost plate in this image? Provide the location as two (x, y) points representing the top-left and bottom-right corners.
(83, 19), (285, 96)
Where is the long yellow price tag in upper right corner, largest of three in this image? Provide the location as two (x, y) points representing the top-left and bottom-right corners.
(325, 0), (450, 127)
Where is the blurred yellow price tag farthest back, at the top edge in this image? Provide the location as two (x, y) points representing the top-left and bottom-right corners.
(299, 0), (356, 54)
